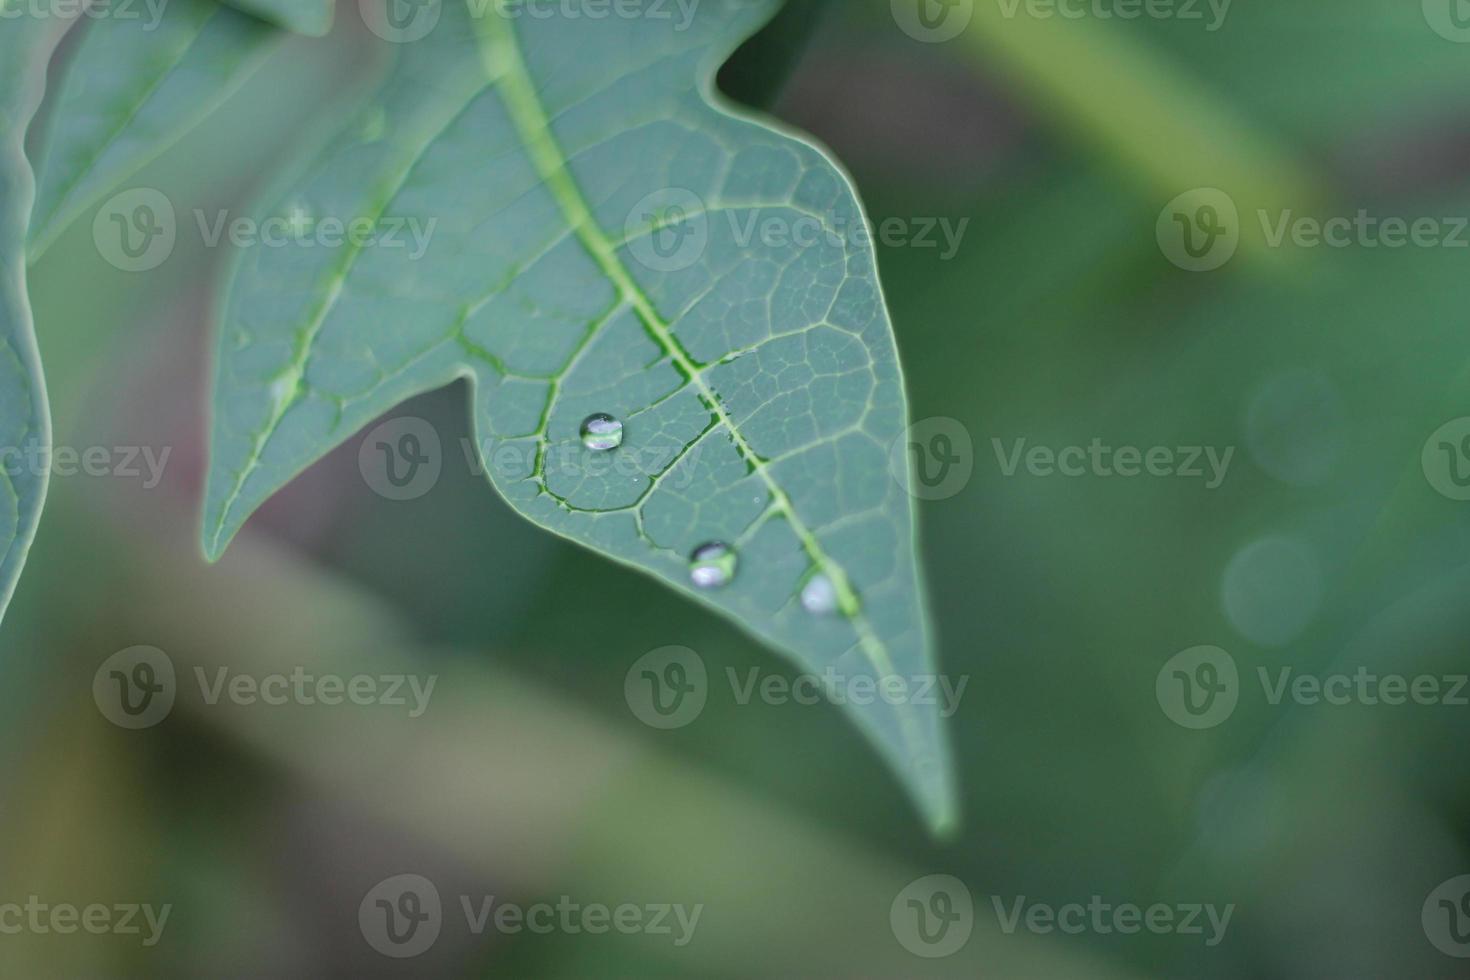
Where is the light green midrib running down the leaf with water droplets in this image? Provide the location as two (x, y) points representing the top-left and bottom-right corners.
(479, 13), (923, 775)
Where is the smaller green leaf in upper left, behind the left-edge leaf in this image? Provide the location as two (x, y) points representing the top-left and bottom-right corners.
(29, 0), (284, 262)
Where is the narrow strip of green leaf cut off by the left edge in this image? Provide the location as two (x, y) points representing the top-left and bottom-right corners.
(0, 11), (68, 613)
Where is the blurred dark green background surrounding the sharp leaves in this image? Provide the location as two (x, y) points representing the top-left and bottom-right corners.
(0, 0), (1470, 979)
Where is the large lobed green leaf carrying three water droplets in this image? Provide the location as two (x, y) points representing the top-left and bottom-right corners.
(204, 0), (954, 826)
